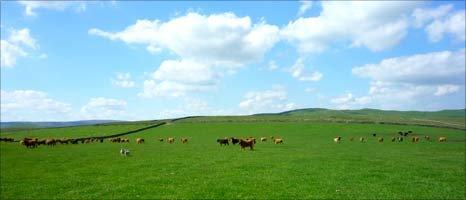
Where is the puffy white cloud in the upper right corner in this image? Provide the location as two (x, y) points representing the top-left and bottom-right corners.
(412, 4), (466, 42)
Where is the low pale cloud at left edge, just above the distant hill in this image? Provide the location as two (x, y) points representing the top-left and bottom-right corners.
(1, 90), (71, 121)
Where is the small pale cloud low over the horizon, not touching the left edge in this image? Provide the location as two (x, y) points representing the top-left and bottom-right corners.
(81, 97), (127, 119)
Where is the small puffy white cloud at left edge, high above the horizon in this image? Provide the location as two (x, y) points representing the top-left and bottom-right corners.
(0, 28), (39, 67)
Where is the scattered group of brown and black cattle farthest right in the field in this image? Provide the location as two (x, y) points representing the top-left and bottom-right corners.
(333, 131), (447, 143)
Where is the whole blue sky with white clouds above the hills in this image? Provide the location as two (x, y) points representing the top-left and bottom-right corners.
(0, 1), (465, 122)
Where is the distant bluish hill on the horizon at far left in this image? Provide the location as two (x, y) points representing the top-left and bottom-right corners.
(0, 120), (122, 129)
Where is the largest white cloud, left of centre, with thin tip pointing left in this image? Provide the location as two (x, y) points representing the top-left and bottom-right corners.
(89, 12), (279, 98)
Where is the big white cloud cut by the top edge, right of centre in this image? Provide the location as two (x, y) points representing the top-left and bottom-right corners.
(281, 1), (419, 53)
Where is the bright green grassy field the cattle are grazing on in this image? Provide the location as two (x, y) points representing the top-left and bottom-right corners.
(0, 120), (465, 199)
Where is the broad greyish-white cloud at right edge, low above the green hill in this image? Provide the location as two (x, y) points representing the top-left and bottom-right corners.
(353, 49), (465, 110)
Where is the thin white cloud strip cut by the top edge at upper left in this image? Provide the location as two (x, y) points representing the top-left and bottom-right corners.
(18, 1), (86, 16)
